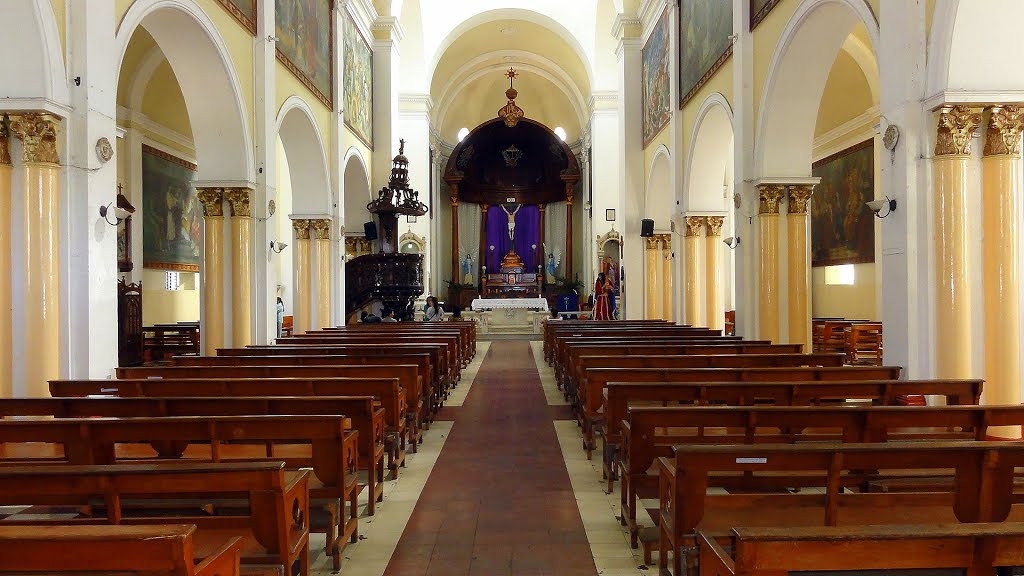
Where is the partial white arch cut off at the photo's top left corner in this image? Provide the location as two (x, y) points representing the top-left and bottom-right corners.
(0, 0), (71, 107)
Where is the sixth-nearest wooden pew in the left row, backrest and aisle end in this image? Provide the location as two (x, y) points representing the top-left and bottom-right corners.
(116, 364), (429, 452)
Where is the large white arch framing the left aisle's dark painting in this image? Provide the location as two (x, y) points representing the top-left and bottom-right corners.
(115, 0), (256, 181)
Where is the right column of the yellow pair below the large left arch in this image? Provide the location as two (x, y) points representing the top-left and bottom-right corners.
(224, 188), (253, 347)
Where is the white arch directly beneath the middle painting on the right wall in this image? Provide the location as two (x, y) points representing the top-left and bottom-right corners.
(683, 92), (733, 212)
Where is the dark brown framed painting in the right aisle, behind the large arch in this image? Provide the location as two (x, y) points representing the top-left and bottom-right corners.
(810, 140), (874, 266)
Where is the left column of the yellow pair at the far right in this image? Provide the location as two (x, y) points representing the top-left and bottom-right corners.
(932, 106), (978, 380)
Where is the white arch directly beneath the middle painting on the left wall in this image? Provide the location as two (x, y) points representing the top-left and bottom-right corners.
(278, 95), (332, 214)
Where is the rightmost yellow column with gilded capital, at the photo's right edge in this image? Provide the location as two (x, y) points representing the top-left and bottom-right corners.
(982, 106), (1024, 432)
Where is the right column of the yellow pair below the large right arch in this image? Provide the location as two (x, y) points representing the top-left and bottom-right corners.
(785, 184), (814, 352)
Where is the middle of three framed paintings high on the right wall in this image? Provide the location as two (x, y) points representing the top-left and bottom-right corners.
(679, 0), (732, 108)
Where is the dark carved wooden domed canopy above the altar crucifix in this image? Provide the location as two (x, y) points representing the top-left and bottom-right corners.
(444, 118), (580, 205)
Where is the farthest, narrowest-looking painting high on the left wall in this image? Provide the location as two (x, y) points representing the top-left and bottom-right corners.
(342, 9), (374, 149)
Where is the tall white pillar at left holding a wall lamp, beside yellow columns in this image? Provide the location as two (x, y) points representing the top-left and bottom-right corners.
(65, 0), (117, 378)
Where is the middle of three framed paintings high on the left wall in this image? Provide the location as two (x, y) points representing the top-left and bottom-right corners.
(274, 0), (334, 110)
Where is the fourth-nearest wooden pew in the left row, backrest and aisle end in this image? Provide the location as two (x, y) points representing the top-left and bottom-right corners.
(0, 396), (385, 516)
